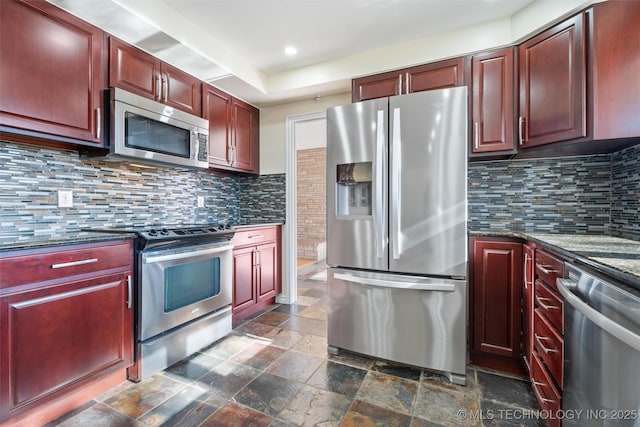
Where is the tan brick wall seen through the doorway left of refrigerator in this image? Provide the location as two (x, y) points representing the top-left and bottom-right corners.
(296, 148), (327, 260)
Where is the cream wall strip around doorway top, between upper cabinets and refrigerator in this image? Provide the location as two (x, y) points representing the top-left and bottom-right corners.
(260, 92), (351, 175)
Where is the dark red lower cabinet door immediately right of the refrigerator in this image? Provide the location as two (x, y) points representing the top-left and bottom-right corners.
(472, 240), (522, 359)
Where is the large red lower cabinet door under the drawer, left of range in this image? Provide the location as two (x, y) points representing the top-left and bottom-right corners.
(0, 273), (133, 417)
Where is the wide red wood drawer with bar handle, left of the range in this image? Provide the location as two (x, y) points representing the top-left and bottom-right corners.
(0, 241), (133, 289)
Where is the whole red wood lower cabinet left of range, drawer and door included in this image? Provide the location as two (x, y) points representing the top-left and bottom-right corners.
(0, 241), (133, 425)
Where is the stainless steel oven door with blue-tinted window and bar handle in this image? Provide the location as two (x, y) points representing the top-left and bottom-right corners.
(138, 241), (233, 341)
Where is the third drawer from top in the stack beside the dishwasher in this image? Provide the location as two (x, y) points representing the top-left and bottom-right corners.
(533, 309), (564, 389)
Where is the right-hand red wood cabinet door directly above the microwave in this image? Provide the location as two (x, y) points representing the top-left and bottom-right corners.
(160, 62), (202, 116)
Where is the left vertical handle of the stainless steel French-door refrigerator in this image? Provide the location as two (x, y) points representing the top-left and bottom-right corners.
(373, 110), (387, 258)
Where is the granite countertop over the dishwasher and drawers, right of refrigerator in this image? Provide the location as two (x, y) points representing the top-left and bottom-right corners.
(469, 230), (640, 289)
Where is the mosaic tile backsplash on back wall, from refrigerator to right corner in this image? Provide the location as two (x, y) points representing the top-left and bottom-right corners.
(468, 155), (612, 234)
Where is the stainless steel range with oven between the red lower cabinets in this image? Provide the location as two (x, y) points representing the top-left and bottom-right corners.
(91, 225), (235, 381)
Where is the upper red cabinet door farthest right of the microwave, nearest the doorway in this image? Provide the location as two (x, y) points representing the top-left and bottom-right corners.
(231, 98), (260, 173)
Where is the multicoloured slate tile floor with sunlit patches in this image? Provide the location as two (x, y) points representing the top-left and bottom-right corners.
(48, 266), (543, 427)
